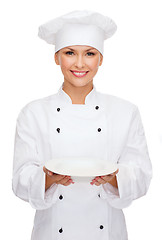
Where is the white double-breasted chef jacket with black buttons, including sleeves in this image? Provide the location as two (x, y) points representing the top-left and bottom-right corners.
(13, 84), (152, 240)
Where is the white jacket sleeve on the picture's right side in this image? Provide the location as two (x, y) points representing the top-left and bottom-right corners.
(101, 108), (152, 209)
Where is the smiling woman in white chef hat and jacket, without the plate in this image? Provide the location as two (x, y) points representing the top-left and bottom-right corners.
(13, 11), (152, 240)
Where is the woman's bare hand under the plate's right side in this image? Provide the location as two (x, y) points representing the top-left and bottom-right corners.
(91, 169), (119, 188)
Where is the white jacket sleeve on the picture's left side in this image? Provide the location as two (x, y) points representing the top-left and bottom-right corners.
(12, 107), (57, 210)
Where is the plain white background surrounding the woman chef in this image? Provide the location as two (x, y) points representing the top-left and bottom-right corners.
(0, 0), (162, 240)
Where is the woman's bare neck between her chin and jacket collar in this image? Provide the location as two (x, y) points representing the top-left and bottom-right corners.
(62, 81), (93, 104)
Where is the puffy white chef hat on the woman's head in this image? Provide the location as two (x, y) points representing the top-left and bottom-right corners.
(38, 11), (117, 54)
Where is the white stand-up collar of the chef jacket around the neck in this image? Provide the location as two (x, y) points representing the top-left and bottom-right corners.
(58, 83), (96, 106)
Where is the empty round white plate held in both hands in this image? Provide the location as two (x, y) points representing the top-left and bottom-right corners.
(45, 158), (117, 177)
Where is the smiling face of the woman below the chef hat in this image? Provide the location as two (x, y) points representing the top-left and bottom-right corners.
(55, 45), (103, 87)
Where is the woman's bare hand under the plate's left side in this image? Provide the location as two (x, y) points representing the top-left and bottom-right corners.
(43, 167), (74, 190)
